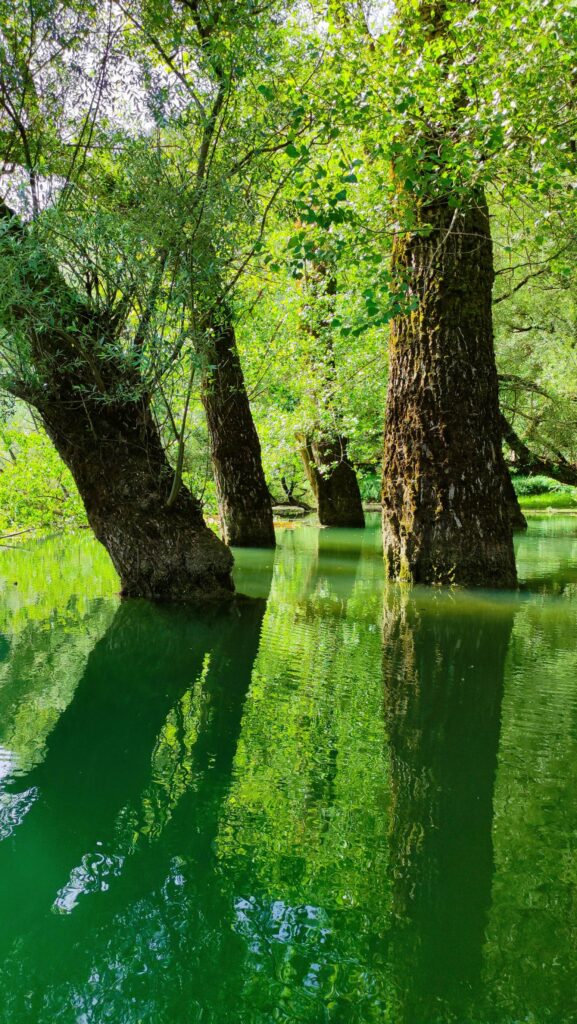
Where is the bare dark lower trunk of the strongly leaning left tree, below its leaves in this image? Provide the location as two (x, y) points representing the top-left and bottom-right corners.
(36, 390), (234, 601)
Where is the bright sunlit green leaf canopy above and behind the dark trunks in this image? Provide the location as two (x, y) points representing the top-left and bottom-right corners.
(0, 0), (577, 526)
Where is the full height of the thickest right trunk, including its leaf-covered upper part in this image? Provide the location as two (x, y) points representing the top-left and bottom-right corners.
(375, 0), (516, 587)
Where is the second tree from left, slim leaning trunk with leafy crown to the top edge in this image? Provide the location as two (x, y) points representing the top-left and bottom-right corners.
(119, 0), (317, 547)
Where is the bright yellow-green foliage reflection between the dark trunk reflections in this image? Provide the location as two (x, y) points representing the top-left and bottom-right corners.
(212, 528), (387, 1024)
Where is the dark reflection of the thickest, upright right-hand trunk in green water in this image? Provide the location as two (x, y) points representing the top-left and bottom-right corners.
(383, 589), (513, 1024)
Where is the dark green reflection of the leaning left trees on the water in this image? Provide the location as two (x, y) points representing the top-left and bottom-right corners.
(0, 593), (265, 1024)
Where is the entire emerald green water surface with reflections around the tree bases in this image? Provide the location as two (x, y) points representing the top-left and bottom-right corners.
(0, 517), (577, 1024)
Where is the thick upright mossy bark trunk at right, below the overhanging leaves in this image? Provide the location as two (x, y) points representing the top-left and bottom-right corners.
(382, 195), (517, 587)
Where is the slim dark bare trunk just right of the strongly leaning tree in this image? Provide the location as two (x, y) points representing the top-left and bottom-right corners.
(202, 316), (275, 548)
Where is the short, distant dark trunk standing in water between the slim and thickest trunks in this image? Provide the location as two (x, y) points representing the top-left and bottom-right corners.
(299, 437), (365, 526)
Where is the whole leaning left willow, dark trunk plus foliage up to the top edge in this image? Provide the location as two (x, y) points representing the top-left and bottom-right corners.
(0, 4), (233, 599)
